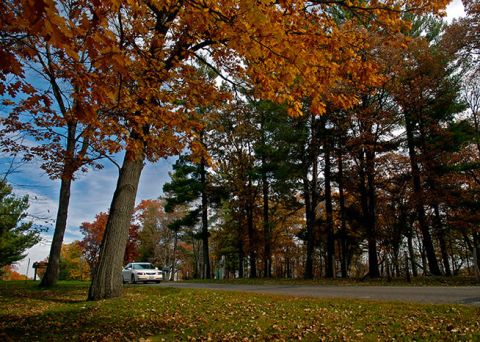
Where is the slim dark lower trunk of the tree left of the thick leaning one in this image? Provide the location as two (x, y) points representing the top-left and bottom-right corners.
(40, 177), (72, 287)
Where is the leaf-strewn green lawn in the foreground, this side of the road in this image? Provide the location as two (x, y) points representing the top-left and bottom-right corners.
(0, 281), (480, 341)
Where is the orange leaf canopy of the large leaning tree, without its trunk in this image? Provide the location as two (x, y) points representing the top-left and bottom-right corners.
(0, 0), (447, 171)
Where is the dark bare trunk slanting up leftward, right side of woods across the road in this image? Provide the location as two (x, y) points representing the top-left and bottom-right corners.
(405, 113), (441, 275)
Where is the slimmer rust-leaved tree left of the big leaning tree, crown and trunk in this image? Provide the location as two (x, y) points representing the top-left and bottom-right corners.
(0, 0), (122, 286)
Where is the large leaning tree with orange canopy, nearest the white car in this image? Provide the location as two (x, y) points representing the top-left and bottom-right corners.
(2, 0), (447, 299)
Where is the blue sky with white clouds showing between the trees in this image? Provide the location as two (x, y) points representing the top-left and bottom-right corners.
(0, 0), (465, 277)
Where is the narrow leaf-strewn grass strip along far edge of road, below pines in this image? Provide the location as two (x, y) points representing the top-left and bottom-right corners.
(185, 276), (480, 286)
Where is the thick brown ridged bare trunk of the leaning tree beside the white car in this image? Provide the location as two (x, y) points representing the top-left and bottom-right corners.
(88, 152), (145, 300)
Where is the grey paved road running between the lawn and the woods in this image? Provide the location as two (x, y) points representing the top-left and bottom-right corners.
(155, 282), (480, 306)
